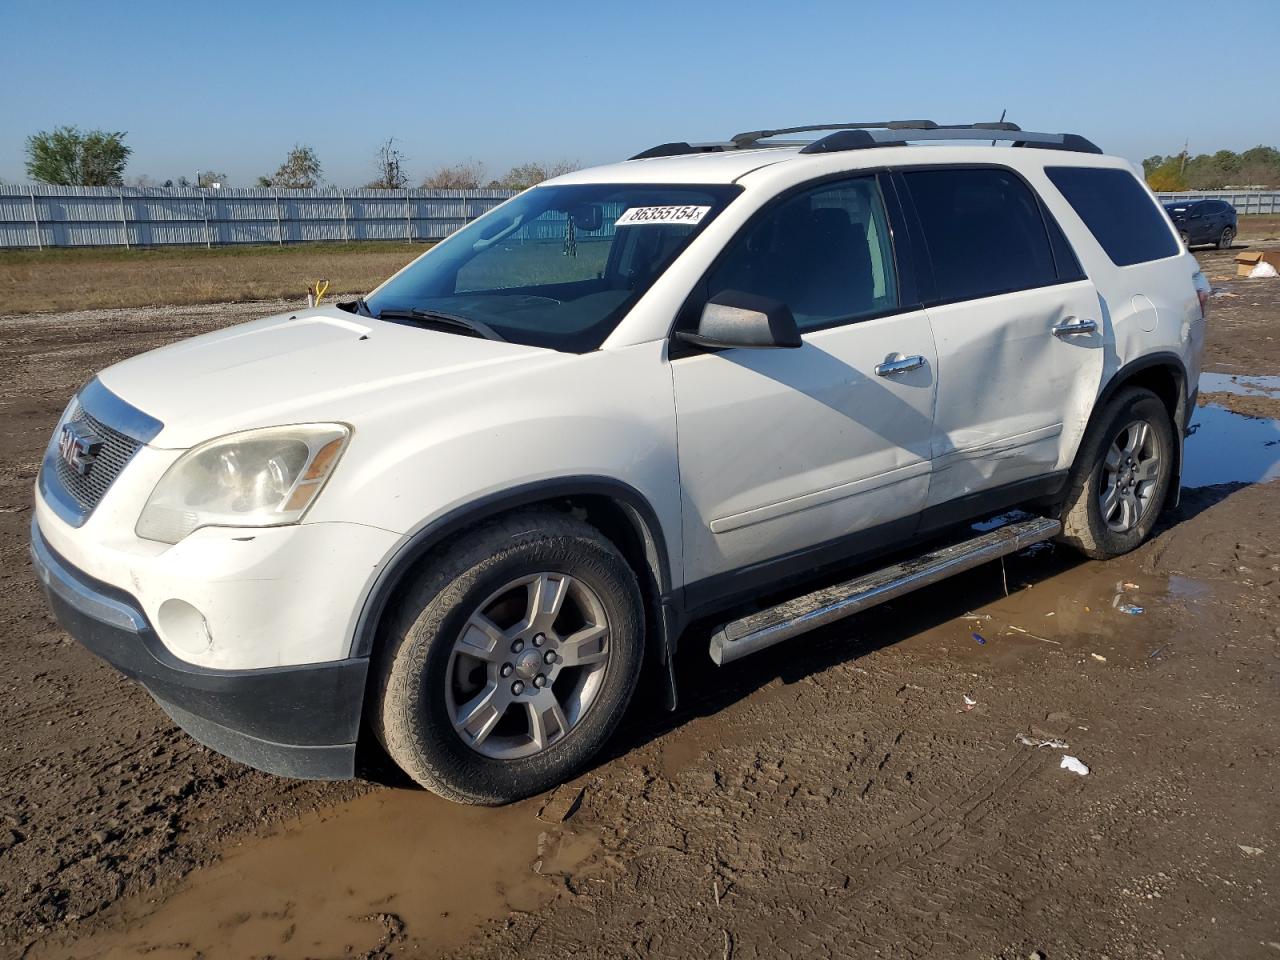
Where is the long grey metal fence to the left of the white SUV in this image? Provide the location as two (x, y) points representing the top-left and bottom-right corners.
(0, 184), (515, 250)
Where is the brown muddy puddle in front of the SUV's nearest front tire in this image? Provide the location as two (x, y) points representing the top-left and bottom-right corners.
(32, 790), (599, 960)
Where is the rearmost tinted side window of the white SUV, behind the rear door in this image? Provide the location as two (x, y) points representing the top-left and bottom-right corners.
(1044, 166), (1179, 266)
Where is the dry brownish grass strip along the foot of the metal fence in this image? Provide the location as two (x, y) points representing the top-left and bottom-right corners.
(0, 216), (1280, 314)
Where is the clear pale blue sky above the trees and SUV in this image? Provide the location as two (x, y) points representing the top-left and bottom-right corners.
(0, 0), (1280, 186)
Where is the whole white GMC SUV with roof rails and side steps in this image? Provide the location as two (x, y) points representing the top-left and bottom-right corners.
(32, 122), (1206, 803)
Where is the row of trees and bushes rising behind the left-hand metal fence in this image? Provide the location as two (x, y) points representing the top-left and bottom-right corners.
(27, 127), (579, 189)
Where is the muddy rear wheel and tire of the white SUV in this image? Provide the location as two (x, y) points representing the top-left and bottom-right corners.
(1059, 387), (1176, 559)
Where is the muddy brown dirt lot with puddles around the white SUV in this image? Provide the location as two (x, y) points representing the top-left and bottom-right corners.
(0, 244), (1280, 960)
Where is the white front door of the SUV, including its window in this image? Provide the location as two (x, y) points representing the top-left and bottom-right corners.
(671, 177), (937, 605)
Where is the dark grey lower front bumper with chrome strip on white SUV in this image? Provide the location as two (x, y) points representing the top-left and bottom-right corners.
(31, 522), (369, 780)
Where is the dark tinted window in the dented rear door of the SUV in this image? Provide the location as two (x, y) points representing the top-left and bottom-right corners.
(904, 168), (1057, 302)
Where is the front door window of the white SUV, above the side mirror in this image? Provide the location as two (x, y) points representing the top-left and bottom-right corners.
(707, 177), (897, 332)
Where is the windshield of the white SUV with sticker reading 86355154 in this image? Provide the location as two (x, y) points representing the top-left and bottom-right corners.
(367, 183), (741, 353)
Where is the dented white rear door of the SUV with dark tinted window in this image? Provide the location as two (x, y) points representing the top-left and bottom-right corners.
(900, 166), (1103, 522)
